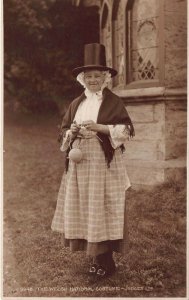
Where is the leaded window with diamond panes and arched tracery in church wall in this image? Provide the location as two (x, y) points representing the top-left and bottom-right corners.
(127, 0), (159, 82)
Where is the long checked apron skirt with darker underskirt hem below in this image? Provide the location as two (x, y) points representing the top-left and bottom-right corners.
(51, 137), (130, 256)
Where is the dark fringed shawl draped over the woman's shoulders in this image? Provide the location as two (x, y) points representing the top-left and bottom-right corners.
(58, 88), (135, 167)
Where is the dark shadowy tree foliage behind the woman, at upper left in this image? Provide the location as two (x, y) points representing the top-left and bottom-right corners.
(4, 0), (98, 111)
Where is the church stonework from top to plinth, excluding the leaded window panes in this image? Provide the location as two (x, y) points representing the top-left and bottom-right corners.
(76, 0), (187, 186)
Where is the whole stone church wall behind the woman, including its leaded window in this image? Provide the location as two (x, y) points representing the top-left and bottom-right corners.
(75, 0), (187, 186)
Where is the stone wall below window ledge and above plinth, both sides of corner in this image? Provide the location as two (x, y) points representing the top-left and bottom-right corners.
(126, 96), (187, 165)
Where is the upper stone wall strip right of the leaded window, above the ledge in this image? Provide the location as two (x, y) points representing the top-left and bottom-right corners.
(164, 0), (187, 88)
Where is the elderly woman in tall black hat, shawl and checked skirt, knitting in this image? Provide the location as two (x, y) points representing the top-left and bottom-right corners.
(52, 43), (134, 278)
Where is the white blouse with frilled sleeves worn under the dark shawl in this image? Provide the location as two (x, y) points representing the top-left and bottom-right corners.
(60, 89), (129, 151)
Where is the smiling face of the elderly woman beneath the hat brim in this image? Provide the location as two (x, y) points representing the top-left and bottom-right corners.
(84, 70), (104, 92)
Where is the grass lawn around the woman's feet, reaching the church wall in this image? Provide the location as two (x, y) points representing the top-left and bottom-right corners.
(4, 112), (186, 297)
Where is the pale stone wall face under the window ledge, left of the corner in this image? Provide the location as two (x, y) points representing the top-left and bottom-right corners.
(127, 102), (165, 161)
